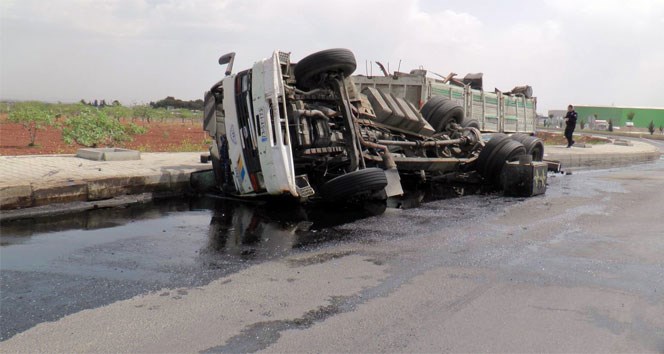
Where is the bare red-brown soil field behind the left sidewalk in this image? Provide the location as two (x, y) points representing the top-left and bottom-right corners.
(0, 116), (209, 156)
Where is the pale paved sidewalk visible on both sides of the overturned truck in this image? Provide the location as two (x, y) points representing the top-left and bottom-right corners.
(0, 141), (661, 216)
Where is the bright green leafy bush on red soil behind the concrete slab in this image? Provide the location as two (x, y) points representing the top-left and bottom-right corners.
(62, 108), (146, 147)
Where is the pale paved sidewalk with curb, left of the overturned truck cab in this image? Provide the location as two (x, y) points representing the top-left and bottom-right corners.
(0, 153), (211, 214)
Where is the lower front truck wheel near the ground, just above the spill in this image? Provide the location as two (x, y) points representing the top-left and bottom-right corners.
(321, 167), (387, 202)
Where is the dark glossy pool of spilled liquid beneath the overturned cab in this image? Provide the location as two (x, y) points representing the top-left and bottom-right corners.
(0, 185), (486, 340)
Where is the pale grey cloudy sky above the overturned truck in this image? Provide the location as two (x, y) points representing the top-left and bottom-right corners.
(0, 0), (664, 113)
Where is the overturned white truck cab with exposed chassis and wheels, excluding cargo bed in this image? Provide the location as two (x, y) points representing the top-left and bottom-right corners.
(204, 49), (546, 202)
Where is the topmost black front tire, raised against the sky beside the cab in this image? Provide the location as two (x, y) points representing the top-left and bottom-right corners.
(293, 48), (357, 90)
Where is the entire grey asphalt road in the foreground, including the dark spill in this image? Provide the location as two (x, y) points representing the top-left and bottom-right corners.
(0, 160), (664, 352)
